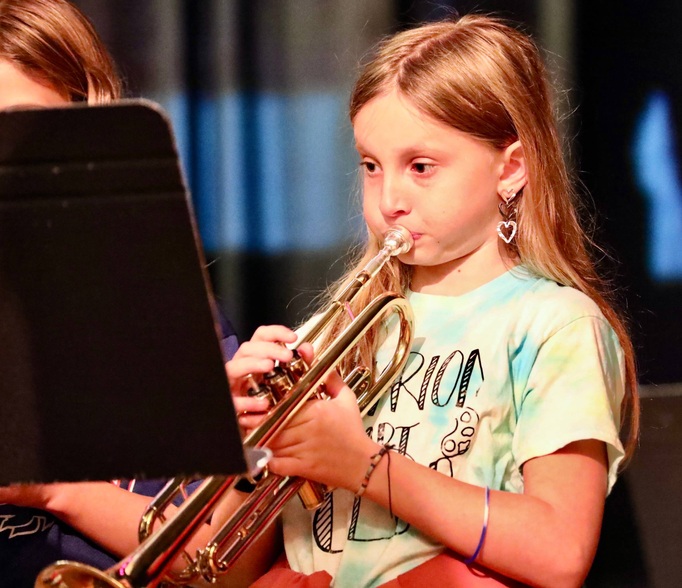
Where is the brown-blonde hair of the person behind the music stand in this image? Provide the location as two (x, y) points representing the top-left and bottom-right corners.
(0, 0), (122, 104)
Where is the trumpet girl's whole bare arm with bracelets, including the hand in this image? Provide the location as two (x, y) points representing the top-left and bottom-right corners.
(264, 378), (607, 587)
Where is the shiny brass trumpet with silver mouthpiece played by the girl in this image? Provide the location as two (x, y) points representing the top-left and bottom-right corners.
(35, 226), (413, 588)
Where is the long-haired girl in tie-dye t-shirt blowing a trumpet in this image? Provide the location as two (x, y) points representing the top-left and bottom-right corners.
(228, 15), (638, 587)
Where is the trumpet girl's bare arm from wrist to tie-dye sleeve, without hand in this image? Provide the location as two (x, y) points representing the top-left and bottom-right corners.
(365, 440), (606, 587)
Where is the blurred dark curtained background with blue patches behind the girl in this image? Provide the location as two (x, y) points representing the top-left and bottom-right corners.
(70, 0), (682, 587)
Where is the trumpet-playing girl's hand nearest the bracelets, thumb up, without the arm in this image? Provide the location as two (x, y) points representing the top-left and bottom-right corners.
(262, 372), (379, 492)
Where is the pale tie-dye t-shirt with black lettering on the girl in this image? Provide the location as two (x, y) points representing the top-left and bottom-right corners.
(284, 268), (624, 588)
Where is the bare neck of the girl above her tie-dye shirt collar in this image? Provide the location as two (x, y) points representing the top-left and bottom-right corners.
(410, 240), (519, 296)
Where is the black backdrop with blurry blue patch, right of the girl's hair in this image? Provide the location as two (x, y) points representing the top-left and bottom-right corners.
(577, 0), (682, 383)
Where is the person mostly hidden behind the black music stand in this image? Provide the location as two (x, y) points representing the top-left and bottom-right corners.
(0, 0), (237, 588)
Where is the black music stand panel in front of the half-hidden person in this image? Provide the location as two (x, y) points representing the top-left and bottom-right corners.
(0, 101), (247, 484)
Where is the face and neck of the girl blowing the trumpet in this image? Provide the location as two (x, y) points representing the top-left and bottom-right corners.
(353, 91), (507, 294)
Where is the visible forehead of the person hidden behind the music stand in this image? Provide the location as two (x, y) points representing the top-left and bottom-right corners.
(0, 58), (68, 110)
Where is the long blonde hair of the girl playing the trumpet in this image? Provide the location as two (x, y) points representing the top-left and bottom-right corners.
(318, 15), (639, 464)
